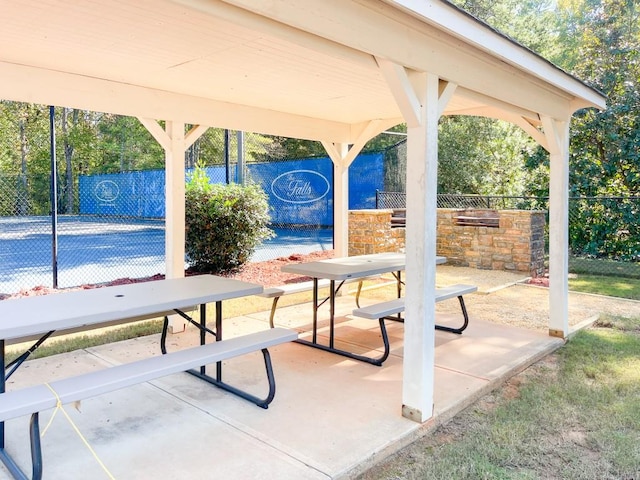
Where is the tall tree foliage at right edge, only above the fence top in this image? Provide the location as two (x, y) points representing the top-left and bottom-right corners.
(559, 0), (640, 196)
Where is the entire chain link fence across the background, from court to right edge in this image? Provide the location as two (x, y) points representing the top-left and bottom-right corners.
(0, 112), (640, 294)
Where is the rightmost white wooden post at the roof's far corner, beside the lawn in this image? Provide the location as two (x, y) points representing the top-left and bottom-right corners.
(542, 117), (569, 338)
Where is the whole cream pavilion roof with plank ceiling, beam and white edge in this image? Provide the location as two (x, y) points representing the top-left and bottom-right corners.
(0, 0), (605, 143)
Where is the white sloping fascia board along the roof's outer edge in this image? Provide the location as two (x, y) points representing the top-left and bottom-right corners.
(383, 0), (606, 108)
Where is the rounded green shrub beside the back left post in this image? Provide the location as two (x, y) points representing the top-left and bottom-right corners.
(185, 166), (274, 274)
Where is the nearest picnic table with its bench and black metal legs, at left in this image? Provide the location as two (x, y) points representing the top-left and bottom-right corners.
(0, 275), (297, 479)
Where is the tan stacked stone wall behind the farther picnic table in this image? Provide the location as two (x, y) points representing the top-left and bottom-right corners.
(349, 208), (545, 277)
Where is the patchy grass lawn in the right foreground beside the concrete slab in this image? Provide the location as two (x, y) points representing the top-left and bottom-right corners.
(361, 316), (640, 480)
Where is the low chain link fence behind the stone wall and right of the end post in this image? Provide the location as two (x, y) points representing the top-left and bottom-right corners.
(376, 191), (640, 278)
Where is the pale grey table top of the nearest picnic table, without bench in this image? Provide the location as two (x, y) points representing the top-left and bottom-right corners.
(0, 275), (262, 340)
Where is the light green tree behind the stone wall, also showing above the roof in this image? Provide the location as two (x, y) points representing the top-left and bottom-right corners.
(438, 0), (558, 196)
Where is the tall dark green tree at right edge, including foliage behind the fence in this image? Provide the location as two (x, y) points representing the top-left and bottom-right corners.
(559, 0), (640, 261)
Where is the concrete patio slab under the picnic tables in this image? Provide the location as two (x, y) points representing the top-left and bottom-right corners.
(0, 296), (562, 480)
